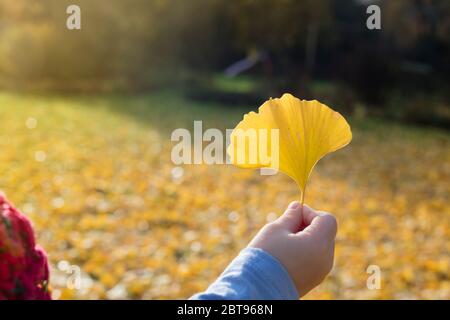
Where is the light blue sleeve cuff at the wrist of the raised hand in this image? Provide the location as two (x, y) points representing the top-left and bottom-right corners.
(191, 248), (299, 300)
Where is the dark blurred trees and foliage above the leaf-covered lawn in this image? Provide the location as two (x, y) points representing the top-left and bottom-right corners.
(0, 0), (450, 122)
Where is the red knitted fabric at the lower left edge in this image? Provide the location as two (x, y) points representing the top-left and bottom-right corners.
(0, 193), (51, 300)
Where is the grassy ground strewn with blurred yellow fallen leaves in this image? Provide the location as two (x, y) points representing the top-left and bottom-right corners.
(0, 92), (450, 299)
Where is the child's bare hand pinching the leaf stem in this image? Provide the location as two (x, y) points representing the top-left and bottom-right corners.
(249, 202), (337, 296)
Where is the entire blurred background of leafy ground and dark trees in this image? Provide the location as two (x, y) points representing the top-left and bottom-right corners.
(0, 0), (450, 299)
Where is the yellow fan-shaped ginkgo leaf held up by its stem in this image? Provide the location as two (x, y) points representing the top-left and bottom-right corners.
(228, 93), (352, 202)
